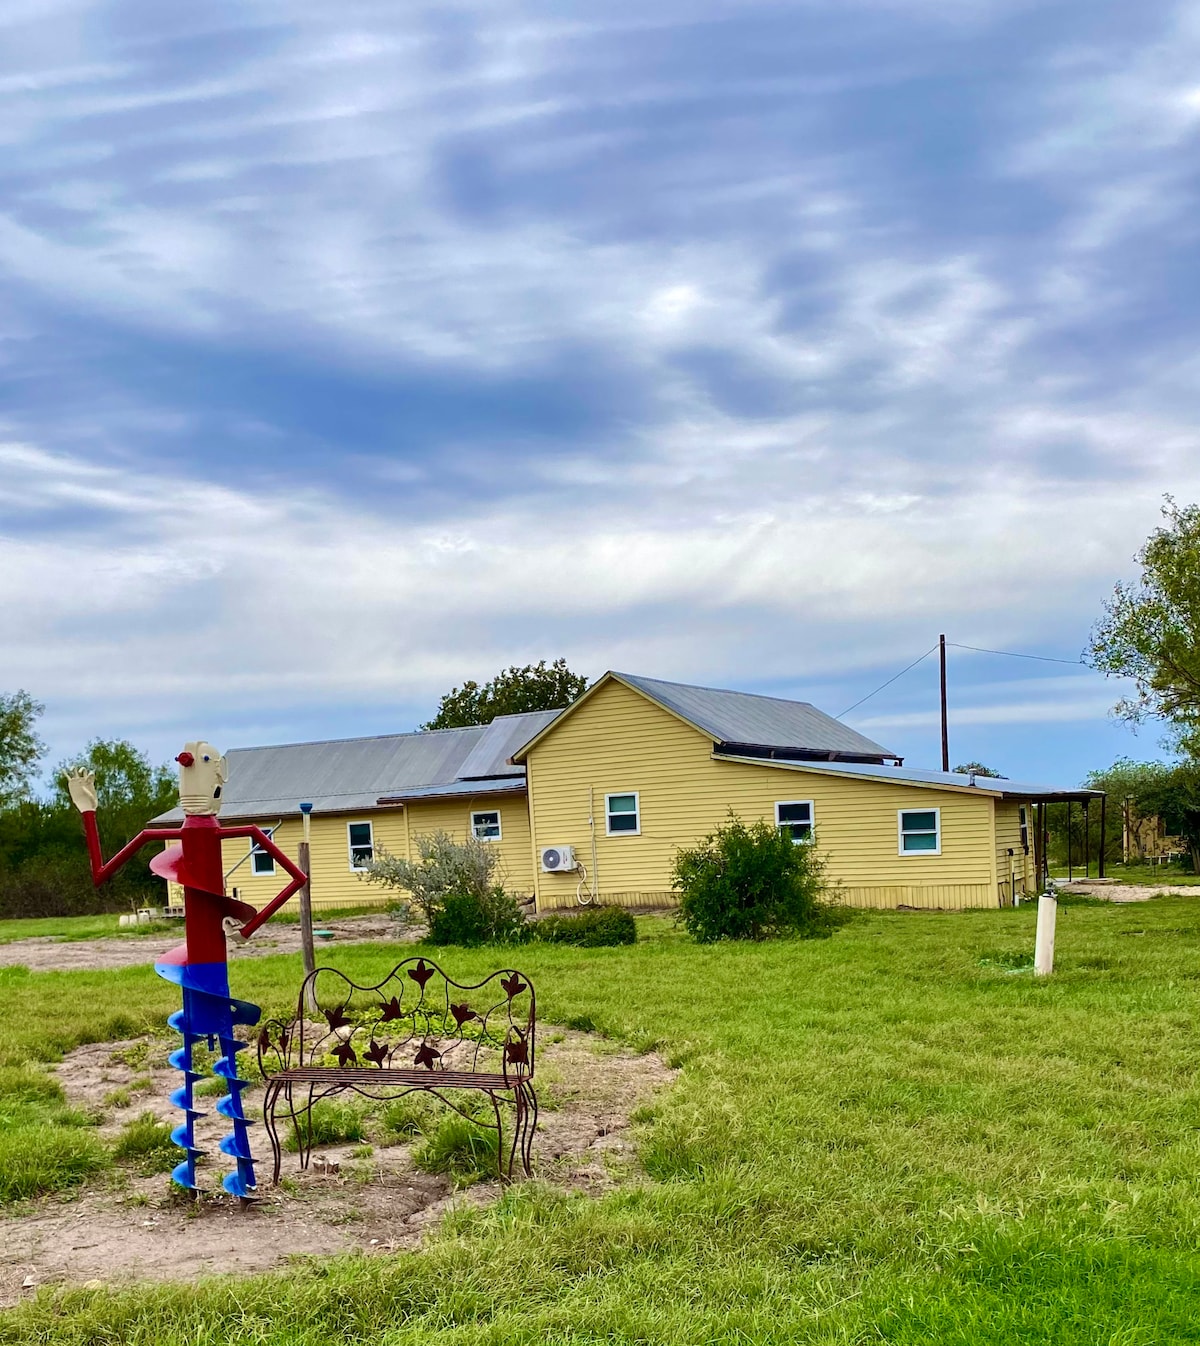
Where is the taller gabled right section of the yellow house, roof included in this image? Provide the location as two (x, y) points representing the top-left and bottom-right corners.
(514, 673), (1088, 910)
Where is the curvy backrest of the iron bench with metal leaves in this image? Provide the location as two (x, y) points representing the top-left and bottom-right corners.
(258, 958), (537, 1079)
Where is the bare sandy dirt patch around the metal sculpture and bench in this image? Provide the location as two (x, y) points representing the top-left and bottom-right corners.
(0, 1028), (677, 1307)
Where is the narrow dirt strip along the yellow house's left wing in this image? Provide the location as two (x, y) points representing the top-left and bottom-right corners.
(0, 913), (411, 972)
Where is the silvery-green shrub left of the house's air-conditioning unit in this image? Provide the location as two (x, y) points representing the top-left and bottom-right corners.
(365, 832), (525, 945)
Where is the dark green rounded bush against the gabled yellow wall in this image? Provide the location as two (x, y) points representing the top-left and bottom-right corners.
(671, 814), (830, 944)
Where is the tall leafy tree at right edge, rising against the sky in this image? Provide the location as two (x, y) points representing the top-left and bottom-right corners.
(1084, 495), (1200, 756)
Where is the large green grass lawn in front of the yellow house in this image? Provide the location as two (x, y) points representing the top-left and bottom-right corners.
(0, 898), (1200, 1346)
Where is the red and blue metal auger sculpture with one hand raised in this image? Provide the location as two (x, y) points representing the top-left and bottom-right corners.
(67, 742), (307, 1198)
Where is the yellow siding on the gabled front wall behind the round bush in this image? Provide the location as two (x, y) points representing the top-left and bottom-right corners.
(527, 681), (998, 910)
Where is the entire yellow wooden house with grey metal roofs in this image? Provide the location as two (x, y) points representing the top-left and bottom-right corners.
(159, 673), (1095, 910)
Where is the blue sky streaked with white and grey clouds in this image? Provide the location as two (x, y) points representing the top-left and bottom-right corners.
(0, 0), (1200, 783)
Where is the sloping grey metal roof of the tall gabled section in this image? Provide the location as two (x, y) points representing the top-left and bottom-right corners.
(613, 673), (897, 756)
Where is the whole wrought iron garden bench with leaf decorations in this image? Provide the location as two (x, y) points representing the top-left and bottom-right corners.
(258, 958), (538, 1183)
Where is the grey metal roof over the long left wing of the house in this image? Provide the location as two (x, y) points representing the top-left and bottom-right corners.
(155, 711), (558, 822)
